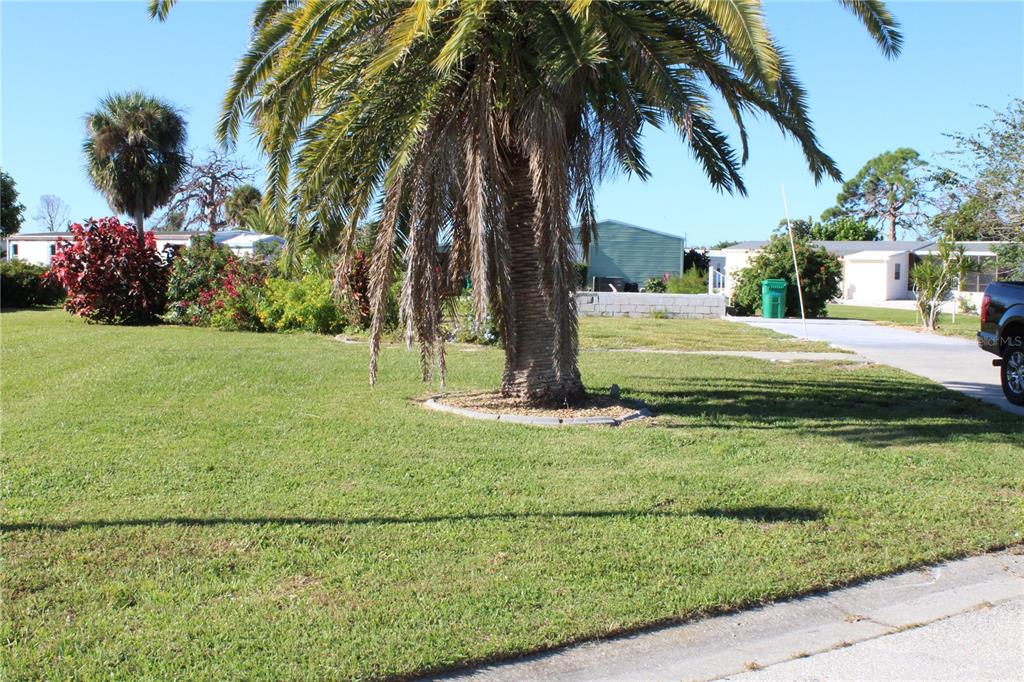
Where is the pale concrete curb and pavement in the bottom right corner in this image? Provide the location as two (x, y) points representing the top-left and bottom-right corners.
(436, 550), (1024, 682)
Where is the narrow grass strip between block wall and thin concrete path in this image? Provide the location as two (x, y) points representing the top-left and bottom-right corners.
(580, 317), (831, 352)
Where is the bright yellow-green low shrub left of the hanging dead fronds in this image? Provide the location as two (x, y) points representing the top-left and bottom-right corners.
(260, 272), (345, 334)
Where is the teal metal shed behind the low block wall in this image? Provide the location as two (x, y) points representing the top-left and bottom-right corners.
(587, 220), (684, 288)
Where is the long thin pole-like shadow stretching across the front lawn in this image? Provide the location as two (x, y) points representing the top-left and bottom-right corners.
(0, 507), (824, 532)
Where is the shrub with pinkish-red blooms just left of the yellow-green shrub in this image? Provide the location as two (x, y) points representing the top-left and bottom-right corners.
(210, 255), (267, 332)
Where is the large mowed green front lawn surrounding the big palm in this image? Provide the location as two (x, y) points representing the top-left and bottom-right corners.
(0, 311), (1024, 680)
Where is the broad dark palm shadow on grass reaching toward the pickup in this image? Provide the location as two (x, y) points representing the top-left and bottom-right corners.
(639, 372), (1024, 447)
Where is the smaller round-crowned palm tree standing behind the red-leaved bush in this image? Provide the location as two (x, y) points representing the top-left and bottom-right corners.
(83, 92), (188, 243)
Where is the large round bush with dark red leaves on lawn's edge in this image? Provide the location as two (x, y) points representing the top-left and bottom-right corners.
(46, 218), (167, 324)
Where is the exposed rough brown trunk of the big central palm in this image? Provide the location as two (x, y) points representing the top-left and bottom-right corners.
(502, 160), (585, 407)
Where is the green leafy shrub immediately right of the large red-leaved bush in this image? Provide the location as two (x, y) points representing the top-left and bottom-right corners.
(167, 235), (231, 327)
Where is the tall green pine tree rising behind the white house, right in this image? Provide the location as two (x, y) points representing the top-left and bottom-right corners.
(821, 147), (927, 242)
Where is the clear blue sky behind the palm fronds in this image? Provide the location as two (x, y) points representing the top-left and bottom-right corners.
(0, 0), (1024, 244)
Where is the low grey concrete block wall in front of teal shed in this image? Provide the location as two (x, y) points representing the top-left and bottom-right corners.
(577, 291), (725, 319)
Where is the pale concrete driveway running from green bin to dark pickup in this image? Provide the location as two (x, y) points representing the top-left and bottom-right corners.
(730, 317), (1024, 416)
